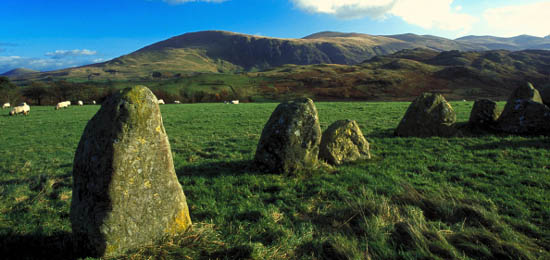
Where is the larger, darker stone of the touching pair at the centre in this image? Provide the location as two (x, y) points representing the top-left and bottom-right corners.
(254, 98), (321, 173)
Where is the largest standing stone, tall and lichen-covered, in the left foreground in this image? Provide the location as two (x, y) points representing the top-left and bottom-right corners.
(70, 86), (191, 257)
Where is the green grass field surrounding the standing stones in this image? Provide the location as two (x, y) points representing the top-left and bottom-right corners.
(0, 102), (550, 259)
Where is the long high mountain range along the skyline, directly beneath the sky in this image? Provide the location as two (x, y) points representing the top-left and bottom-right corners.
(7, 31), (550, 83)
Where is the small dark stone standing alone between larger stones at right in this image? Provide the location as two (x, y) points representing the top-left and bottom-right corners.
(468, 99), (500, 129)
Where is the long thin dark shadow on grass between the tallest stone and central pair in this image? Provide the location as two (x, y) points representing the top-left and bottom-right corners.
(176, 160), (259, 177)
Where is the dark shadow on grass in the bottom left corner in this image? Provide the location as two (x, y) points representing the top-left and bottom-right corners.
(0, 232), (84, 259)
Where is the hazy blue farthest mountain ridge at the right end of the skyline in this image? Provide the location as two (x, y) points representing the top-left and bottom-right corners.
(456, 35), (550, 51)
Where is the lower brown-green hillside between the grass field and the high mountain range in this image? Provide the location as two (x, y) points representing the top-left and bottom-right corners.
(12, 48), (550, 104)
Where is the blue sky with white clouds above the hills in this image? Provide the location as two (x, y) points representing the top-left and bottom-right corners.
(0, 0), (550, 73)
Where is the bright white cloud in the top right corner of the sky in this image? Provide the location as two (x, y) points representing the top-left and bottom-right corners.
(483, 1), (550, 37)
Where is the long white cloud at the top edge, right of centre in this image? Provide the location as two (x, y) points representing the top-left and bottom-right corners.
(292, 0), (478, 32)
